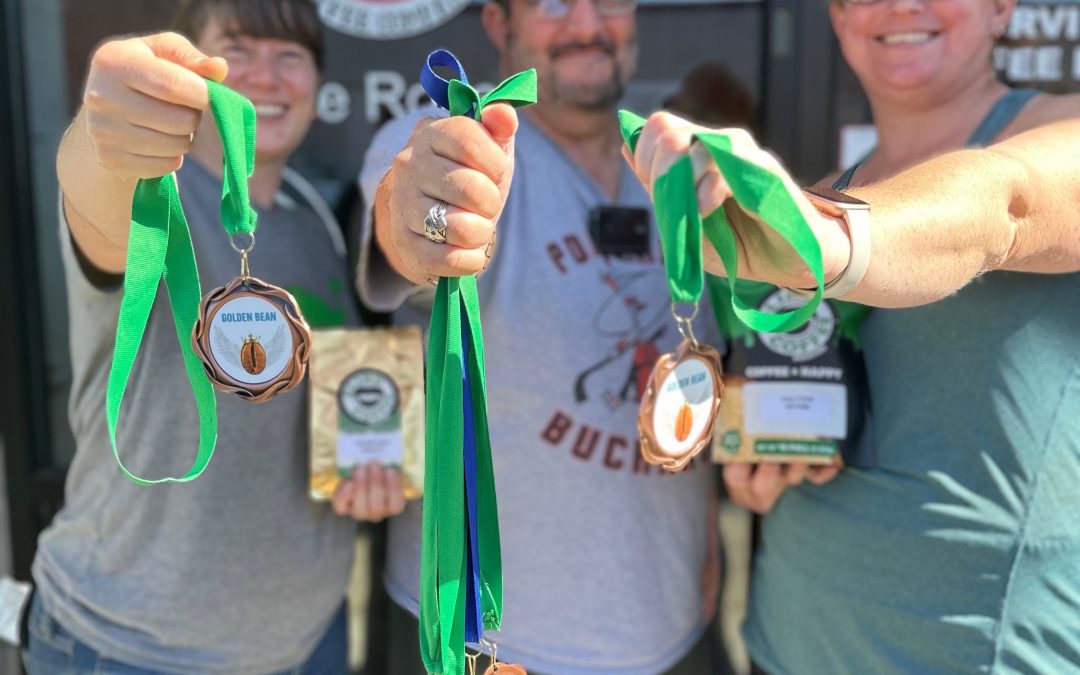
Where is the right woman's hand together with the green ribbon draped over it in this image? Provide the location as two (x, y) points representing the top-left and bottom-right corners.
(620, 111), (848, 332)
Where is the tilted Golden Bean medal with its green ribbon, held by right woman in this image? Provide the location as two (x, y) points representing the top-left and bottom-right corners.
(619, 110), (824, 471)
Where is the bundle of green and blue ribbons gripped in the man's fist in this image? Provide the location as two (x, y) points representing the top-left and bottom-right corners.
(420, 50), (536, 675)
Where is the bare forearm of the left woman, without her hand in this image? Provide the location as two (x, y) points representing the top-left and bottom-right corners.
(56, 111), (137, 273)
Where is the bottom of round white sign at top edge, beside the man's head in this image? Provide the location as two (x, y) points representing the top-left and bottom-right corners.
(316, 0), (470, 40)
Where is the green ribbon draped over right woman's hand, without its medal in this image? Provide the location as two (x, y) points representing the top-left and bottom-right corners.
(619, 110), (825, 333)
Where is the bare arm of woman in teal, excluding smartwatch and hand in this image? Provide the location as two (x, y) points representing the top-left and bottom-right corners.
(846, 119), (1080, 307)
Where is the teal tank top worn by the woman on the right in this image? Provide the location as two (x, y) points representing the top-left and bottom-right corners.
(744, 91), (1080, 675)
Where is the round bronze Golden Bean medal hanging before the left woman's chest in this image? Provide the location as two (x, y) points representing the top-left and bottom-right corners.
(191, 234), (311, 403)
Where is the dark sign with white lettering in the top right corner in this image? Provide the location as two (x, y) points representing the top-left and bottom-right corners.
(994, 0), (1080, 93)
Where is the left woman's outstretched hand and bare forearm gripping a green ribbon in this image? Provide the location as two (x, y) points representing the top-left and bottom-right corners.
(56, 33), (227, 273)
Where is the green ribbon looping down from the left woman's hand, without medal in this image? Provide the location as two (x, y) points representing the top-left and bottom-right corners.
(105, 80), (256, 485)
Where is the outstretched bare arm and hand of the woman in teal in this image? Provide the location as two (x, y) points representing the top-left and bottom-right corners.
(627, 105), (1080, 307)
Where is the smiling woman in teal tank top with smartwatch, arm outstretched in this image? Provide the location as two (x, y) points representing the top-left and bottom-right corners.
(631, 0), (1080, 675)
